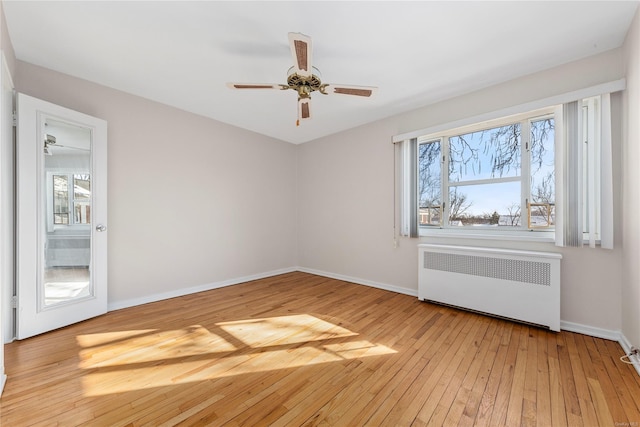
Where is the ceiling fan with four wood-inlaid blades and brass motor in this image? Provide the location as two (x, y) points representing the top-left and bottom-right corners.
(227, 33), (377, 125)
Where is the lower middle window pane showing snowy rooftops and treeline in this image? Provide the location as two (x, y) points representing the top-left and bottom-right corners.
(449, 181), (521, 227)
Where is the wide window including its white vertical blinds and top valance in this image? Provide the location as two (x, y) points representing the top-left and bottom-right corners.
(393, 80), (625, 249)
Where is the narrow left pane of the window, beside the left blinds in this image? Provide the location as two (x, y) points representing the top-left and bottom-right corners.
(418, 140), (442, 225)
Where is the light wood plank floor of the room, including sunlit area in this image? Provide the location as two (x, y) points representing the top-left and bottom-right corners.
(0, 273), (640, 427)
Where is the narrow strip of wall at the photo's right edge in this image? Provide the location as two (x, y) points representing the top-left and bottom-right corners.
(622, 11), (640, 348)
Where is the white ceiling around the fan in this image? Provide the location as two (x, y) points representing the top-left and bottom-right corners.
(3, 0), (638, 143)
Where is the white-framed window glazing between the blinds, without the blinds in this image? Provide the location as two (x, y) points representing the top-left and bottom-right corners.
(417, 109), (555, 230)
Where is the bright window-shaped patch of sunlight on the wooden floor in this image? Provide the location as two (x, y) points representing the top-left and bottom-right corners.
(77, 314), (395, 396)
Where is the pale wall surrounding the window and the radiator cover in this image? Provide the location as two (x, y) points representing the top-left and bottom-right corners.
(298, 49), (624, 331)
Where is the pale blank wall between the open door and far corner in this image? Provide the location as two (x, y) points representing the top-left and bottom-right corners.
(15, 61), (297, 308)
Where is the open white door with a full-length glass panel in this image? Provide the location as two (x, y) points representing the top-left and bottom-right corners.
(16, 94), (107, 339)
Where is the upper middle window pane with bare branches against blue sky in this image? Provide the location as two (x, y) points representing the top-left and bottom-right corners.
(449, 123), (521, 182)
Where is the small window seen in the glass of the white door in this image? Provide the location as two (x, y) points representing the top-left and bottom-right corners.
(50, 173), (91, 225)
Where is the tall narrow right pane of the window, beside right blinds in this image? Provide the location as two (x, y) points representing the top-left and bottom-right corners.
(529, 118), (556, 227)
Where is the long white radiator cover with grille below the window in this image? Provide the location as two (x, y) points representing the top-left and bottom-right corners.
(418, 244), (562, 331)
